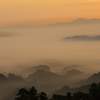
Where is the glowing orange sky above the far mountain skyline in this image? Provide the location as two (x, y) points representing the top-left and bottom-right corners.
(0, 0), (100, 27)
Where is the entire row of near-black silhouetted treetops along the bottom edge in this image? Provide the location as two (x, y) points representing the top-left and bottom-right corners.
(15, 83), (100, 100)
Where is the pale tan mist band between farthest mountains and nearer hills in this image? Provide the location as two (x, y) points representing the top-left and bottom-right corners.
(0, 19), (100, 72)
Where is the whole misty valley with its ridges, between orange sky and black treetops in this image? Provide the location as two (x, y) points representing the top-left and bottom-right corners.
(0, 18), (100, 100)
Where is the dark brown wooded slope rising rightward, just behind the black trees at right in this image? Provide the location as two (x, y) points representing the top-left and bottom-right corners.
(49, 72), (100, 97)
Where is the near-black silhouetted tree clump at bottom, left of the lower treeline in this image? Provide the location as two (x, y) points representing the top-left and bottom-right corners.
(15, 86), (48, 100)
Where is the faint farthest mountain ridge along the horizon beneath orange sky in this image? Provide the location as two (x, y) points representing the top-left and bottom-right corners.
(1, 18), (100, 28)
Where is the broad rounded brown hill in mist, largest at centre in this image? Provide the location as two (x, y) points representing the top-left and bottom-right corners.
(26, 70), (65, 93)
